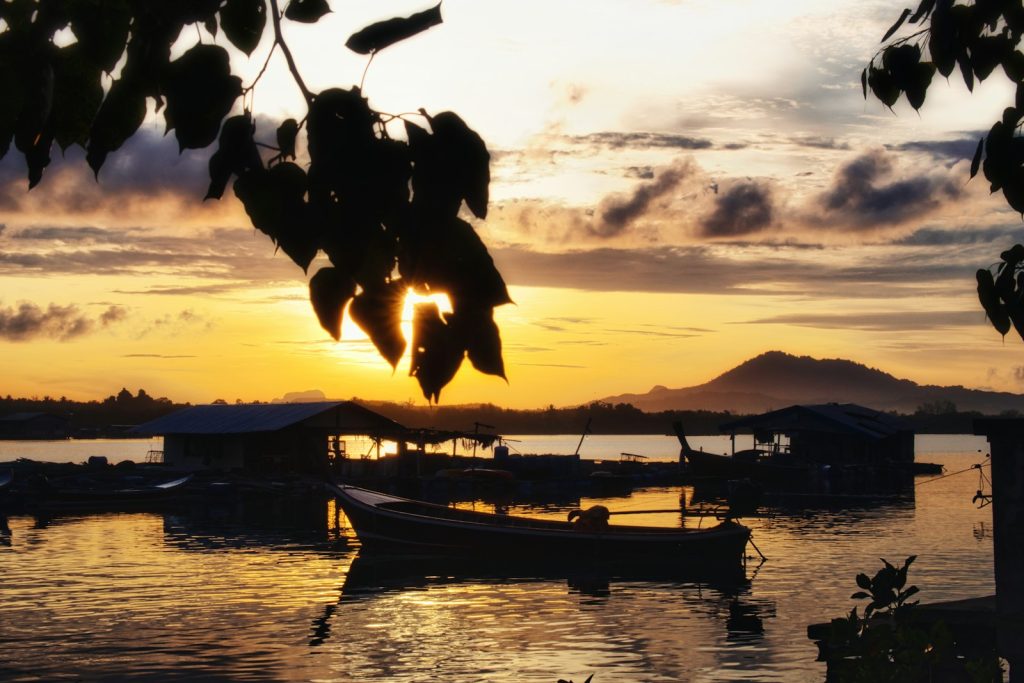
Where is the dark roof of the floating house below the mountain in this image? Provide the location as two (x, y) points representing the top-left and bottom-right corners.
(719, 403), (912, 440)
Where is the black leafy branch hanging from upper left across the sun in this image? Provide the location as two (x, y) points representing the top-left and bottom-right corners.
(0, 0), (511, 401)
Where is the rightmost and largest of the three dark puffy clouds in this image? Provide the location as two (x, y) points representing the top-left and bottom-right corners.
(820, 150), (961, 228)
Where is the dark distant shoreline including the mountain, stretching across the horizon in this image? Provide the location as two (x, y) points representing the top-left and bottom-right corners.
(0, 351), (1024, 437)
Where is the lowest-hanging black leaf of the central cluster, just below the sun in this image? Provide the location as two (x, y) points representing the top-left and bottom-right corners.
(409, 303), (465, 402)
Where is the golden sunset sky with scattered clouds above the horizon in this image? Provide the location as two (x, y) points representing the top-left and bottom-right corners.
(0, 0), (1024, 408)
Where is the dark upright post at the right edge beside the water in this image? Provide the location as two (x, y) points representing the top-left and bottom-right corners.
(974, 418), (1024, 682)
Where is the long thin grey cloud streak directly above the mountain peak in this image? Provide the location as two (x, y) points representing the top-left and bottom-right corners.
(742, 310), (984, 332)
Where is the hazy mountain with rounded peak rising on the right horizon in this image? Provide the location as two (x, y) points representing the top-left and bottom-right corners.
(601, 351), (1024, 415)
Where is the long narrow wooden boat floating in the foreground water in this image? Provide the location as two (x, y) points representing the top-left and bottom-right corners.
(328, 484), (751, 567)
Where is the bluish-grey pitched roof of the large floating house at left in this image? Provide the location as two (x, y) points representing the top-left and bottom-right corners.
(132, 400), (406, 435)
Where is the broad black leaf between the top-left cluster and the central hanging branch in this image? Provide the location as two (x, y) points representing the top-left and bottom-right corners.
(163, 44), (242, 150)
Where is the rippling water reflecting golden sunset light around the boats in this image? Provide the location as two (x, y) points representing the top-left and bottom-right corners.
(0, 436), (994, 683)
